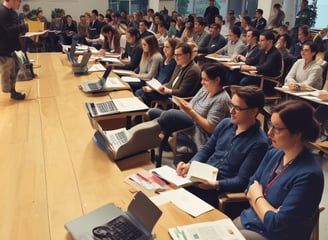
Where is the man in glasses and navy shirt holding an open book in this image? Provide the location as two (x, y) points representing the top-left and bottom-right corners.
(176, 86), (268, 207)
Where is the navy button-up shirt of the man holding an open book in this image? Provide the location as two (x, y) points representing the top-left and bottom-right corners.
(190, 118), (268, 192)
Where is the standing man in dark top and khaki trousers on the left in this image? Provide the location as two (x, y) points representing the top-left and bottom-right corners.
(0, 0), (27, 100)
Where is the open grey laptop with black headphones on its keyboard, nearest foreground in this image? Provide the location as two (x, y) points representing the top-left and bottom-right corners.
(64, 192), (162, 240)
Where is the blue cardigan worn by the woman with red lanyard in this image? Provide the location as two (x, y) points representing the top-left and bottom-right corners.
(240, 149), (324, 240)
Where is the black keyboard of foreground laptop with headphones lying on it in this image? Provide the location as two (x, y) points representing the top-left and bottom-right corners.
(92, 216), (142, 240)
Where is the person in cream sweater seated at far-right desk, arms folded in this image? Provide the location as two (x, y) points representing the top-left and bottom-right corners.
(285, 41), (322, 91)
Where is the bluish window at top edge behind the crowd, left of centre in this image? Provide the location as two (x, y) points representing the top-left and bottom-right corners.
(108, 0), (148, 14)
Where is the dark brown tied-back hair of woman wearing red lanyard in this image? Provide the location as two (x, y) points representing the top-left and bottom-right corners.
(271, 99), (320, 141)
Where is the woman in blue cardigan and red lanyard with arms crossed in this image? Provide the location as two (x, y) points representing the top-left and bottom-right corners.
(234, 100), (324, 240)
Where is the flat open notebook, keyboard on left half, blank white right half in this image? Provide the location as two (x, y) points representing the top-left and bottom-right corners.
(85, 97), (148, 117)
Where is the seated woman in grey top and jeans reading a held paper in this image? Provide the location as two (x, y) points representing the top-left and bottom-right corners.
(148, 64), (230, 155)
